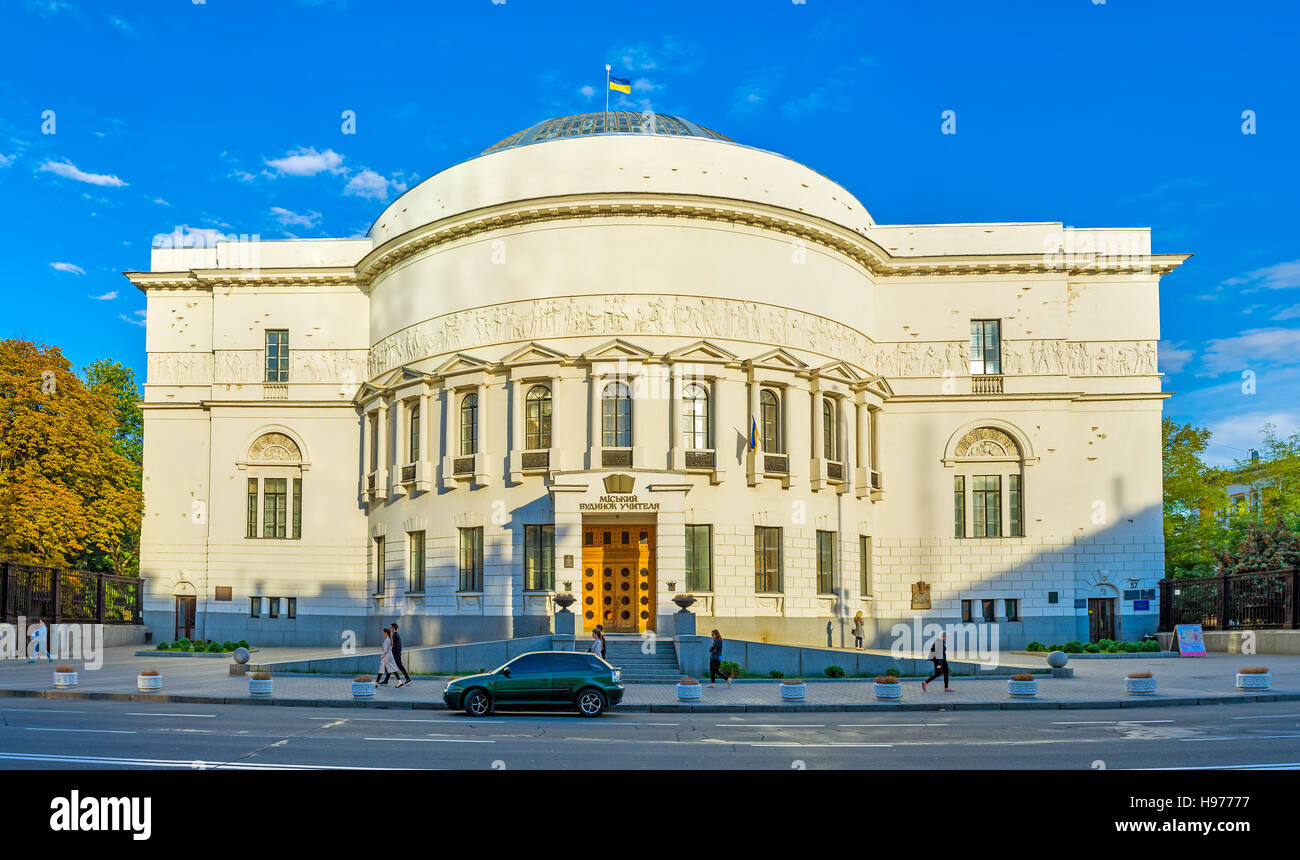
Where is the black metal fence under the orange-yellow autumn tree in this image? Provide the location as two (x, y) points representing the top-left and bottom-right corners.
(0, 561), (144, 624)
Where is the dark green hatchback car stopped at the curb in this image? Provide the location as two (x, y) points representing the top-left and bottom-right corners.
(442, 651), (623, 717)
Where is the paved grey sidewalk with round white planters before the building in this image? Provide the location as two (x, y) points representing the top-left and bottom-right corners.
(0, 647), (1300, 712)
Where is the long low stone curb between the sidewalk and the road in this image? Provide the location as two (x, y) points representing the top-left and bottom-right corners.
(0, 690), (1300, 713)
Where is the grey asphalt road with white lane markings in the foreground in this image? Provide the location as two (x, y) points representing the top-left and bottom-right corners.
(0, 699), (1300, 770)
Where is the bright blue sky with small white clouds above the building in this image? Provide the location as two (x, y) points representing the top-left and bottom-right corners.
(0, 0), (1300, 462)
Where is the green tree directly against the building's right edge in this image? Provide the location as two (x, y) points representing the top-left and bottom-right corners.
(1161, 418), (1227, 577)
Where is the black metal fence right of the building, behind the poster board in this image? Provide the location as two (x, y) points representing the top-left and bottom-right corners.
(1160, 568), (1300, 633)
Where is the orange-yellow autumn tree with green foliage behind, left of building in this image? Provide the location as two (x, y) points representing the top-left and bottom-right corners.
(0, 340), (143, 575)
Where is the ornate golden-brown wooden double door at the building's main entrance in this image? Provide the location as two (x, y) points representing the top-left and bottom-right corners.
(582, 524), (655, 633)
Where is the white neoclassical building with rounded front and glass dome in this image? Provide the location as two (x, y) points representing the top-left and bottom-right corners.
(127, 113), (1186, 647)
